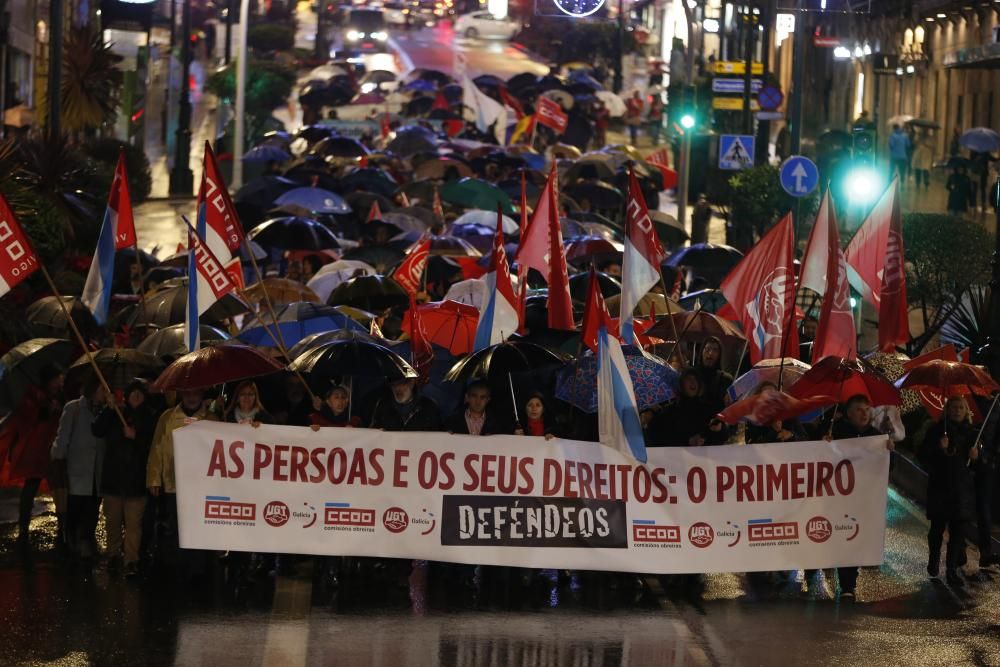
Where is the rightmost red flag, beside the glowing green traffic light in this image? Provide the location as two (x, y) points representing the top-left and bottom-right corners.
(845, 179), (910, 352)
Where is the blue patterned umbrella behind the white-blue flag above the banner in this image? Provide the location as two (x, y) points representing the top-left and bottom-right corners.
(556, 345), (680, 414)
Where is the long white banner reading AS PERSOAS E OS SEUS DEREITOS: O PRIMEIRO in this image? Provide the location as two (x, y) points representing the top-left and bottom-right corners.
(174, 422), (889, 573)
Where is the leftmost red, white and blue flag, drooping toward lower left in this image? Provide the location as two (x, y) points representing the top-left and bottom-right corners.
(80, 151), (136, 324)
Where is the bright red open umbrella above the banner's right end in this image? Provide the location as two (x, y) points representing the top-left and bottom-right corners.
(789, 357), (902, 405)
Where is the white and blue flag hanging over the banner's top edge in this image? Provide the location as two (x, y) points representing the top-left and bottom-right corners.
(597, 327), (646, 463)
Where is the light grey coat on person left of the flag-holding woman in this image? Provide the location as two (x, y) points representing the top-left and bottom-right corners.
(52, 398), (105, 496)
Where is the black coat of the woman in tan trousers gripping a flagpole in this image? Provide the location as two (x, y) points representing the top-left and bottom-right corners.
(91, 403), (156, 498)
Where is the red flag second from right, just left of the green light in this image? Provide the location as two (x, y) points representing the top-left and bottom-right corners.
(799, 190), (858, 364)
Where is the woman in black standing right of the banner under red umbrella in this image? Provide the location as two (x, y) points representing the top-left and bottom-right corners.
(920, 396), (979, 586)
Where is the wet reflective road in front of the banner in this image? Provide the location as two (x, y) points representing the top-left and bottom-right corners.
(0, 494), (1000, 667)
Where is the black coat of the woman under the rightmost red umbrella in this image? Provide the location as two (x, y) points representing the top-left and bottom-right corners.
(920, 417), (977, 520)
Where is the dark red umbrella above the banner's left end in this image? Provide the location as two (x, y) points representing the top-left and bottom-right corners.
(152, 343), (284, 391)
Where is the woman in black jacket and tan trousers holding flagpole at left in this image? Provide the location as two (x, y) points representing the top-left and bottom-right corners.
(91, 380), (159, 577)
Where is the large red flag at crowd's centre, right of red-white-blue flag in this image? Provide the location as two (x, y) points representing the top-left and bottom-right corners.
(517, 166), (575, 331)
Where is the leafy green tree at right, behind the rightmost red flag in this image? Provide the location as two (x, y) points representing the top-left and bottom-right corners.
(903, 213), (993, 354)
